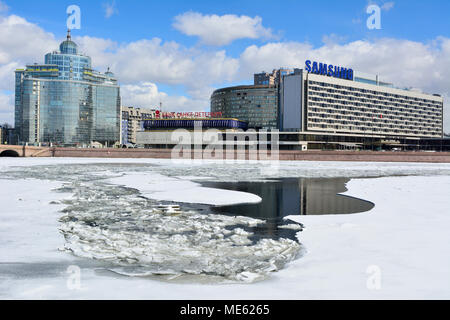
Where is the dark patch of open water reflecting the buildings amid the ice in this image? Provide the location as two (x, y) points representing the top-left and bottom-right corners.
(201, 178), (374, 238)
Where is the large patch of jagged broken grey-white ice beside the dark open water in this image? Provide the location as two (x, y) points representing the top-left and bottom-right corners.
(2, 164), (301, 282)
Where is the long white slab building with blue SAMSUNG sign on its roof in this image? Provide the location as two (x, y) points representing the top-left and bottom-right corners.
(279, 61), (444, 138)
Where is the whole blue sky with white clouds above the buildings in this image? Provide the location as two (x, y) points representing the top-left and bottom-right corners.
(0, 0), (450, 132)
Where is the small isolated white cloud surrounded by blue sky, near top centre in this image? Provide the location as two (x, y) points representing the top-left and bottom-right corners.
(173, 12), (274, 46)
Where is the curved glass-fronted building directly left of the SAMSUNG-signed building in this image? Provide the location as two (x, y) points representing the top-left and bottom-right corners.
(211, 85), (278, 129)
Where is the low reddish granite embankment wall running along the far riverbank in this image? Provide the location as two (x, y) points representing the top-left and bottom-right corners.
(0, 145), (450, 163)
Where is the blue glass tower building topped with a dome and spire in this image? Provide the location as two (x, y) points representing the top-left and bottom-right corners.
(15, 31), (120, 146)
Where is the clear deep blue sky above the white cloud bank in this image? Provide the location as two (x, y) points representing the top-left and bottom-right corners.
(7, 0), (450, 49)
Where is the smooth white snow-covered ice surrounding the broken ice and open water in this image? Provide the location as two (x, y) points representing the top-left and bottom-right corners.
(0, 159), (450, 299)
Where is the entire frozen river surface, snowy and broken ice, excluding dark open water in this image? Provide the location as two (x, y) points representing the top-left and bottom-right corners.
(0, 158), (450, 299)
